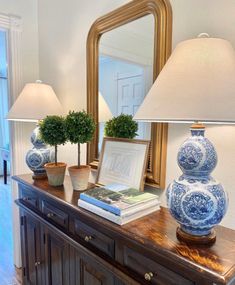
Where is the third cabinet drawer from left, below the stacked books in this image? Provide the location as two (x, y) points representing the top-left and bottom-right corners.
(75, 219), (114, 257)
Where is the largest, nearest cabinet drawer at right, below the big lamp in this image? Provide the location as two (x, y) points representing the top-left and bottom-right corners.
(124, 246), (194, 285)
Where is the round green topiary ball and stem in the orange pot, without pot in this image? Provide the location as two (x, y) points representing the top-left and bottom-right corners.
(39, 116), (67, 165)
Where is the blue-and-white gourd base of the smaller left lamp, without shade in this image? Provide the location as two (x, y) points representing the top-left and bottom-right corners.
(26, 126), (55, 179)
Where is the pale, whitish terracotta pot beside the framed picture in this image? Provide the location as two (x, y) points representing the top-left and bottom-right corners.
(68, 165), (91, 191)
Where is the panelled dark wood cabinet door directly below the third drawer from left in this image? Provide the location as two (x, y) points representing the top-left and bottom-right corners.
(70, 246), (115, 285)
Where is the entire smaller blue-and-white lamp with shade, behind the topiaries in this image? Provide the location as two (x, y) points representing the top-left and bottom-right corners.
(7, 80), (63, 179)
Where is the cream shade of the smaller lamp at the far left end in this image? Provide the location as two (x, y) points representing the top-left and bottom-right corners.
(7, 82), (63, 122)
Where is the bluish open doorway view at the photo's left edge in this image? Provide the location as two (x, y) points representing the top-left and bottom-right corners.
(0, 29), (21, 285)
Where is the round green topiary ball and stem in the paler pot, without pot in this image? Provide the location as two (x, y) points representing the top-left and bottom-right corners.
(65, 111), (95, 167)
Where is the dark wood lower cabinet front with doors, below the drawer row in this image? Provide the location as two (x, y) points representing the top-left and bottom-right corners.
(21, 210), (125, 285)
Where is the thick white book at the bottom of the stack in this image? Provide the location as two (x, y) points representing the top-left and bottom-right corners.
(78, 199), (160, 225)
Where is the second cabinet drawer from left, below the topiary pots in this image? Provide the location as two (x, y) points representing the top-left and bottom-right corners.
(42, 200), (69, 229)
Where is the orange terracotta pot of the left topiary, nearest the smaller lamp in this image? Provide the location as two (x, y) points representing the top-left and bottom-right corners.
(44, 162), (67, 186)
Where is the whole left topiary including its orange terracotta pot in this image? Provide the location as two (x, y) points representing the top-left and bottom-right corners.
(39, 116), (67, 186)
